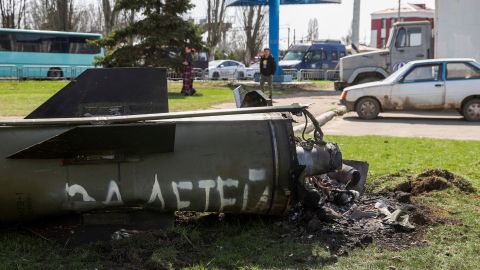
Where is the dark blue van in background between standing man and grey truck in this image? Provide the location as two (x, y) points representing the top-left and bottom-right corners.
(279, 40), (347, 70)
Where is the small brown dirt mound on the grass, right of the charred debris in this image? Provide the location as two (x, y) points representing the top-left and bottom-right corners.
(391, 169), (476, 195)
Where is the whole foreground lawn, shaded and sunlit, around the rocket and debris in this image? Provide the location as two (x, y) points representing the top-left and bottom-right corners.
(0, 136), (480, 269)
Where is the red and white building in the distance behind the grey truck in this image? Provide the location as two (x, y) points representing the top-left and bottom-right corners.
(370, 4), (435, 48)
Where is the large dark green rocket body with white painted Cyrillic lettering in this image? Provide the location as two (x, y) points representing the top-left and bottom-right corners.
(0, 69), (365, 223)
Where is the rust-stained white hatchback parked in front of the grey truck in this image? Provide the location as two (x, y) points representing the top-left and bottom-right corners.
(340, 59), (480, 121)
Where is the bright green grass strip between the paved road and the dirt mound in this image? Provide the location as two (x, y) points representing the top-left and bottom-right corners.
(326, 136), (480, 189)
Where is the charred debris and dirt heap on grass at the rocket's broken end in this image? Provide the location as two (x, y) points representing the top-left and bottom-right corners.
(277, 169), (475, 255)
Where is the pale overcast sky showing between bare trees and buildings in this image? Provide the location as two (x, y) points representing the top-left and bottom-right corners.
(192, 0), (435, 48)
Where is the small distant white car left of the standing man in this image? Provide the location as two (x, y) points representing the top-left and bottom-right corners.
(208, 60), (246, 80)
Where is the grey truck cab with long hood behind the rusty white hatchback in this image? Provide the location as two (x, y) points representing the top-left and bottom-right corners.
(335, 21), (433, 90)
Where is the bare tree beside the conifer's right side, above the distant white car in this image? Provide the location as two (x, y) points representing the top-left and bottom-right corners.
(205, 0), (227, 58)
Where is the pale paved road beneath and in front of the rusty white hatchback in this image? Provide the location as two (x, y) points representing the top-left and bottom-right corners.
(215, 90), (480, 140)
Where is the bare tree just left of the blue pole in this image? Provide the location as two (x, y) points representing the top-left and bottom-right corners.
(240, 6), (266, 64)
